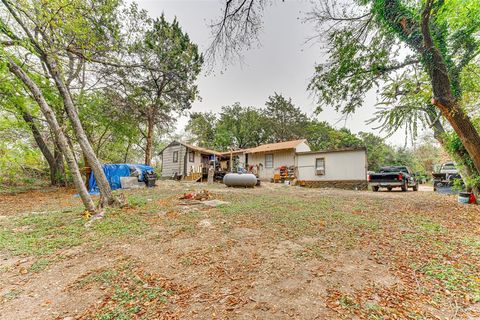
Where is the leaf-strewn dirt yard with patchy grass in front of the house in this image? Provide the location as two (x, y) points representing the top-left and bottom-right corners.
(0, 182), (480, 320)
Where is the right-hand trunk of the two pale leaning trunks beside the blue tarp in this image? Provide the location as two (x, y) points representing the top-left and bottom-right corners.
(44, 57), (120, 207)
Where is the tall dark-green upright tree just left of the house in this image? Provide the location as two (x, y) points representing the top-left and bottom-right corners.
(110, 9), (203, 164)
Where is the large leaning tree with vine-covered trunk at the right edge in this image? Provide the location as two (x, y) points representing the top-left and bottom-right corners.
(310, 0), (480, 185)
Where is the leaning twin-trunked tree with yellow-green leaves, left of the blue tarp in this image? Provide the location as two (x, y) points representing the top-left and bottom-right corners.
(0, 0), (124, 210)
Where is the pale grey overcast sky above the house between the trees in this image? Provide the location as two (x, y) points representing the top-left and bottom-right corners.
(137, 0), (412, 145)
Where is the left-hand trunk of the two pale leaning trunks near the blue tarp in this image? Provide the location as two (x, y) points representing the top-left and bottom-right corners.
(8, 58), (96, 213)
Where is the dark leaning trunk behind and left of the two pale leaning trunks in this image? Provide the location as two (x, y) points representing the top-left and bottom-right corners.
(20, 109), (65, 186)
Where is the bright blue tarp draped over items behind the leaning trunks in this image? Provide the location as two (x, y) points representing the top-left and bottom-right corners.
(88, 163), (153, 194)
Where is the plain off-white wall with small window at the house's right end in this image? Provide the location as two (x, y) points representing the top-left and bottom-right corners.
(296, 150), (367, 181)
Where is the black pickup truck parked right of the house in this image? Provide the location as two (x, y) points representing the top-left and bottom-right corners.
(368, 166), (418, 191)
